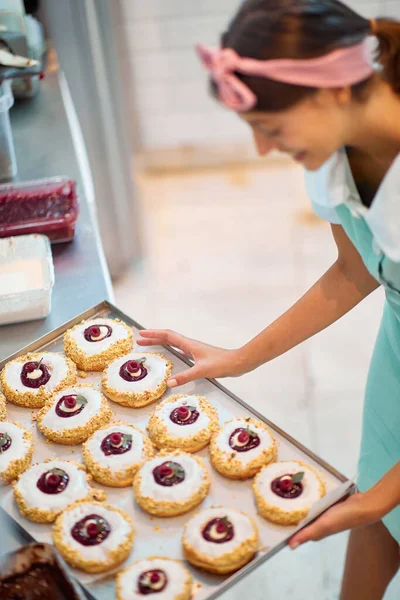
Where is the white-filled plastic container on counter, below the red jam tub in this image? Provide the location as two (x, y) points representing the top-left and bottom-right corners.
(0, 234), (54, 325)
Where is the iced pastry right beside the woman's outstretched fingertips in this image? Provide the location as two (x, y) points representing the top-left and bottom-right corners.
(102, 352), (173, 408)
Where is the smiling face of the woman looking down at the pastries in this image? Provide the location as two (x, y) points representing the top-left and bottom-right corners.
(241, 88), (352, 171)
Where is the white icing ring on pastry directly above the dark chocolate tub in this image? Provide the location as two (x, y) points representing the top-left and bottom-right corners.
(16, 460), (90, 512)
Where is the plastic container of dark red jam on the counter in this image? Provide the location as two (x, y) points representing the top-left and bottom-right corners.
(0, 177), (79, 243)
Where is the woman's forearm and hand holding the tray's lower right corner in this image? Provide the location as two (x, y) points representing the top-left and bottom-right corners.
(289, 462), (400, 550)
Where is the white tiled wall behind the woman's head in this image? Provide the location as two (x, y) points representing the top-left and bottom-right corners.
(123, 0), (400, 155)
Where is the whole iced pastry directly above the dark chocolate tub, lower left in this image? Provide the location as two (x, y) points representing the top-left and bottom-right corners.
(14, 459), (97, 523)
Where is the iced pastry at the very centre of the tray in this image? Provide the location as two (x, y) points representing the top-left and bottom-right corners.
(82, 423), (155, 487)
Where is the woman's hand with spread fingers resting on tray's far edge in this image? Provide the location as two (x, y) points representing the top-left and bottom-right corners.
(136, 329), (246, 387)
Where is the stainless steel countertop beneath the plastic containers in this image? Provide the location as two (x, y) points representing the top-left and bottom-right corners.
(0, 73), (113, 360)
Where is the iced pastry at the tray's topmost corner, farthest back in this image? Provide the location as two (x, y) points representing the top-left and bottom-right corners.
(64, 317), (133, 371)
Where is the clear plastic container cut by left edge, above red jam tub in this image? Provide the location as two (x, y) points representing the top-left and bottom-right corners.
(0, 79), (17, 180)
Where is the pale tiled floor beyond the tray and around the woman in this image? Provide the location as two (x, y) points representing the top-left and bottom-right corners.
(115, 161), (400, 600)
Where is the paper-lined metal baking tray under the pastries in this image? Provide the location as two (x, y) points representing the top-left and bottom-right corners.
(0, 301), (355, 600)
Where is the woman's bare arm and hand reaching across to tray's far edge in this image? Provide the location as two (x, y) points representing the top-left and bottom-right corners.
(138, 225), (379, 387)
